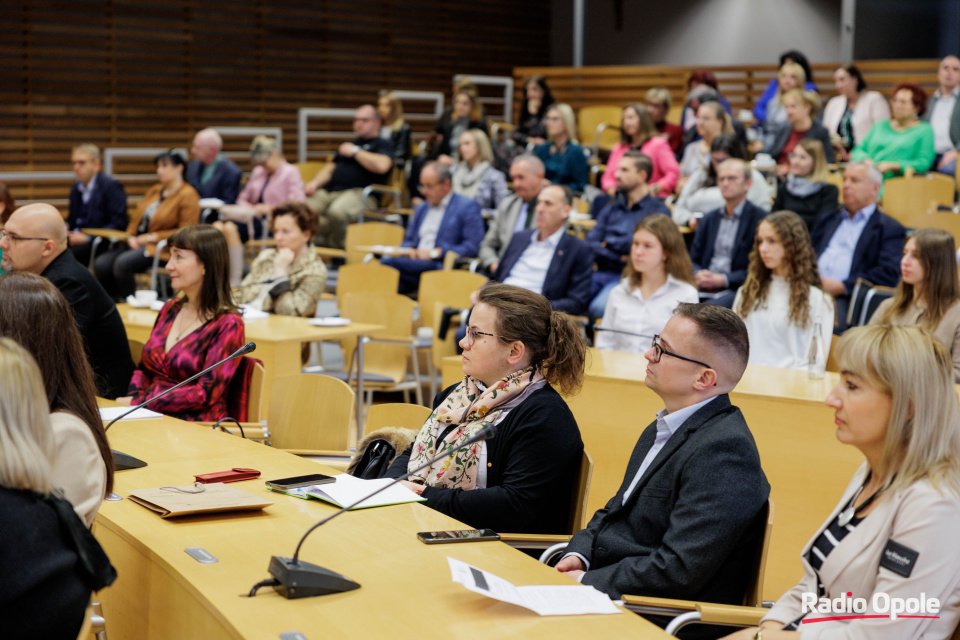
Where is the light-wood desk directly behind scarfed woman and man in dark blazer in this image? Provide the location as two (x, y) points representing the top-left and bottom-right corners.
(443, 349), (863, 600)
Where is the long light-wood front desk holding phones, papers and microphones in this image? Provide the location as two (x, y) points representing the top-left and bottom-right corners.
(94, 403), (666, 640)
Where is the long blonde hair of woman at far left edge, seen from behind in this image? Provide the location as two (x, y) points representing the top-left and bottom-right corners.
(0, 338), (54, 494)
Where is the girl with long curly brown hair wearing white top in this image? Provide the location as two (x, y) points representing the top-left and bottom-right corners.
(733, 211), (833, 371)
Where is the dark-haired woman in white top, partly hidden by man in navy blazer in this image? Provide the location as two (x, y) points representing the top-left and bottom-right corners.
(671, 133), (770, 230)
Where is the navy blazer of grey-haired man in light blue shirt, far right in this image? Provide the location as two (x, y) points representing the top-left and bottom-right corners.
(810, 208), (907, 294)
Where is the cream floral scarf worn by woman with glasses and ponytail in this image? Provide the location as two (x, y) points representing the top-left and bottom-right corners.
(407, 366), (546, 490)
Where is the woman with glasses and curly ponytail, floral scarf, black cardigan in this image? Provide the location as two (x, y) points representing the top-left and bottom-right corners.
(387, 283), (587, 534)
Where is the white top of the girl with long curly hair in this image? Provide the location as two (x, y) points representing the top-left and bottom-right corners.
(733, 276), (834, 371)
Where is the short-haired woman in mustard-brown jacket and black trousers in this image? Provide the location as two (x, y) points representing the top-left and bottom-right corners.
(94, 151), (200, 300)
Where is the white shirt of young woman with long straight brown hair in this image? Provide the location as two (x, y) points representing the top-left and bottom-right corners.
(594, 276), (700, 353)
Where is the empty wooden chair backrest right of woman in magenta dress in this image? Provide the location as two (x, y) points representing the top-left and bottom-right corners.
(267, 373), (356, 451)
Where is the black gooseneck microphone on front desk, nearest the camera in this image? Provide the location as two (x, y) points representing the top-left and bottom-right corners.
(249, 424), (497, 599)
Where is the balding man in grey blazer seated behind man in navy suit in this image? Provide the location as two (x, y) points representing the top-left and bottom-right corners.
(480, 153), (549, 273)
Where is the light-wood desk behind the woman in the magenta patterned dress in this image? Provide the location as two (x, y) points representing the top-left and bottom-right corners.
(117, 303), (386, 434)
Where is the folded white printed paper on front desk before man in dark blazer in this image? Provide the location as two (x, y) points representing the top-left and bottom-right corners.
(447, 556), (623, 616)
